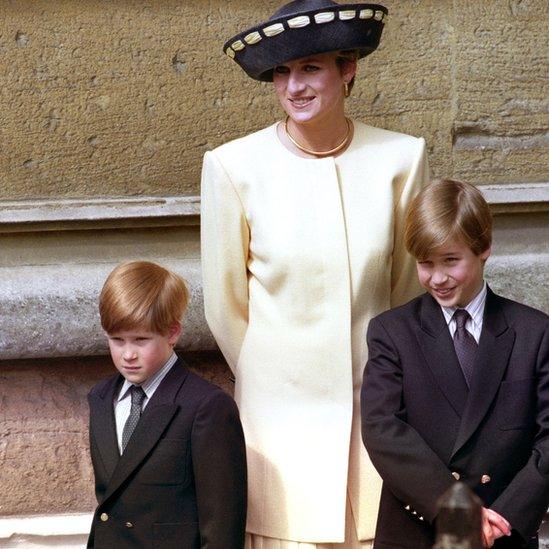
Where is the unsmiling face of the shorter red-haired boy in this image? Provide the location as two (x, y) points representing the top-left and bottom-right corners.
(108, 324), (181, 385)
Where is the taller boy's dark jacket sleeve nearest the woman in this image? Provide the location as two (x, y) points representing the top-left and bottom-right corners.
(361, 319), (454, 522)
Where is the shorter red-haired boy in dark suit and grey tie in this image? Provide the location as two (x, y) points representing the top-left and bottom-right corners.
(88, 262), (247, 549)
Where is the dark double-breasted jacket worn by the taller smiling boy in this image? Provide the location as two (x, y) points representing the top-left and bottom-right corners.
(361, 290), (549, 549)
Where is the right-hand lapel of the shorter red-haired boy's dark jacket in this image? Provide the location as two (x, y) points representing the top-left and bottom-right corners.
(104, 360), (188, 501)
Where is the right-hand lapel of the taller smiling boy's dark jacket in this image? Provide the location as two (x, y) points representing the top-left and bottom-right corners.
(452, 288), (515, 456)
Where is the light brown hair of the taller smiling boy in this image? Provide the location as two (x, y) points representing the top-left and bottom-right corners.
(404, 179), (492, 261)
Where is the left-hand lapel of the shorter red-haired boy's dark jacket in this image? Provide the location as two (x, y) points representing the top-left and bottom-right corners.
(90, 376), (123, 482)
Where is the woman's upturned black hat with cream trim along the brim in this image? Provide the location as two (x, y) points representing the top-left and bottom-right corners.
(223, 0), (388, 82)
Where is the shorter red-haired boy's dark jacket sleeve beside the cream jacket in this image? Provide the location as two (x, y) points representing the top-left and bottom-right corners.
(191, 391), (247, 549)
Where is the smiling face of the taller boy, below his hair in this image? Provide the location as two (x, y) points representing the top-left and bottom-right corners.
(417, 240), (490, 307)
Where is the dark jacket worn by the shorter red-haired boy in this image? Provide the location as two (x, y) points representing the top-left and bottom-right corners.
(88, 361), (247, 549)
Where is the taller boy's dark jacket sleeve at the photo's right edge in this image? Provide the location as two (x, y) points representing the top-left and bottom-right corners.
(491, 327), (549, 541)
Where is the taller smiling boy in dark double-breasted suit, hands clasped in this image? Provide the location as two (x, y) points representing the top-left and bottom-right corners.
(361, 181), (549, 549)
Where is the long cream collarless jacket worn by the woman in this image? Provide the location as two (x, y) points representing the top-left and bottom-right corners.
(201, 122), (427, 542)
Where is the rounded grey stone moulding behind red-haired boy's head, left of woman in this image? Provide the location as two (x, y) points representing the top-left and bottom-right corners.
(0, 261), (214, 359)
